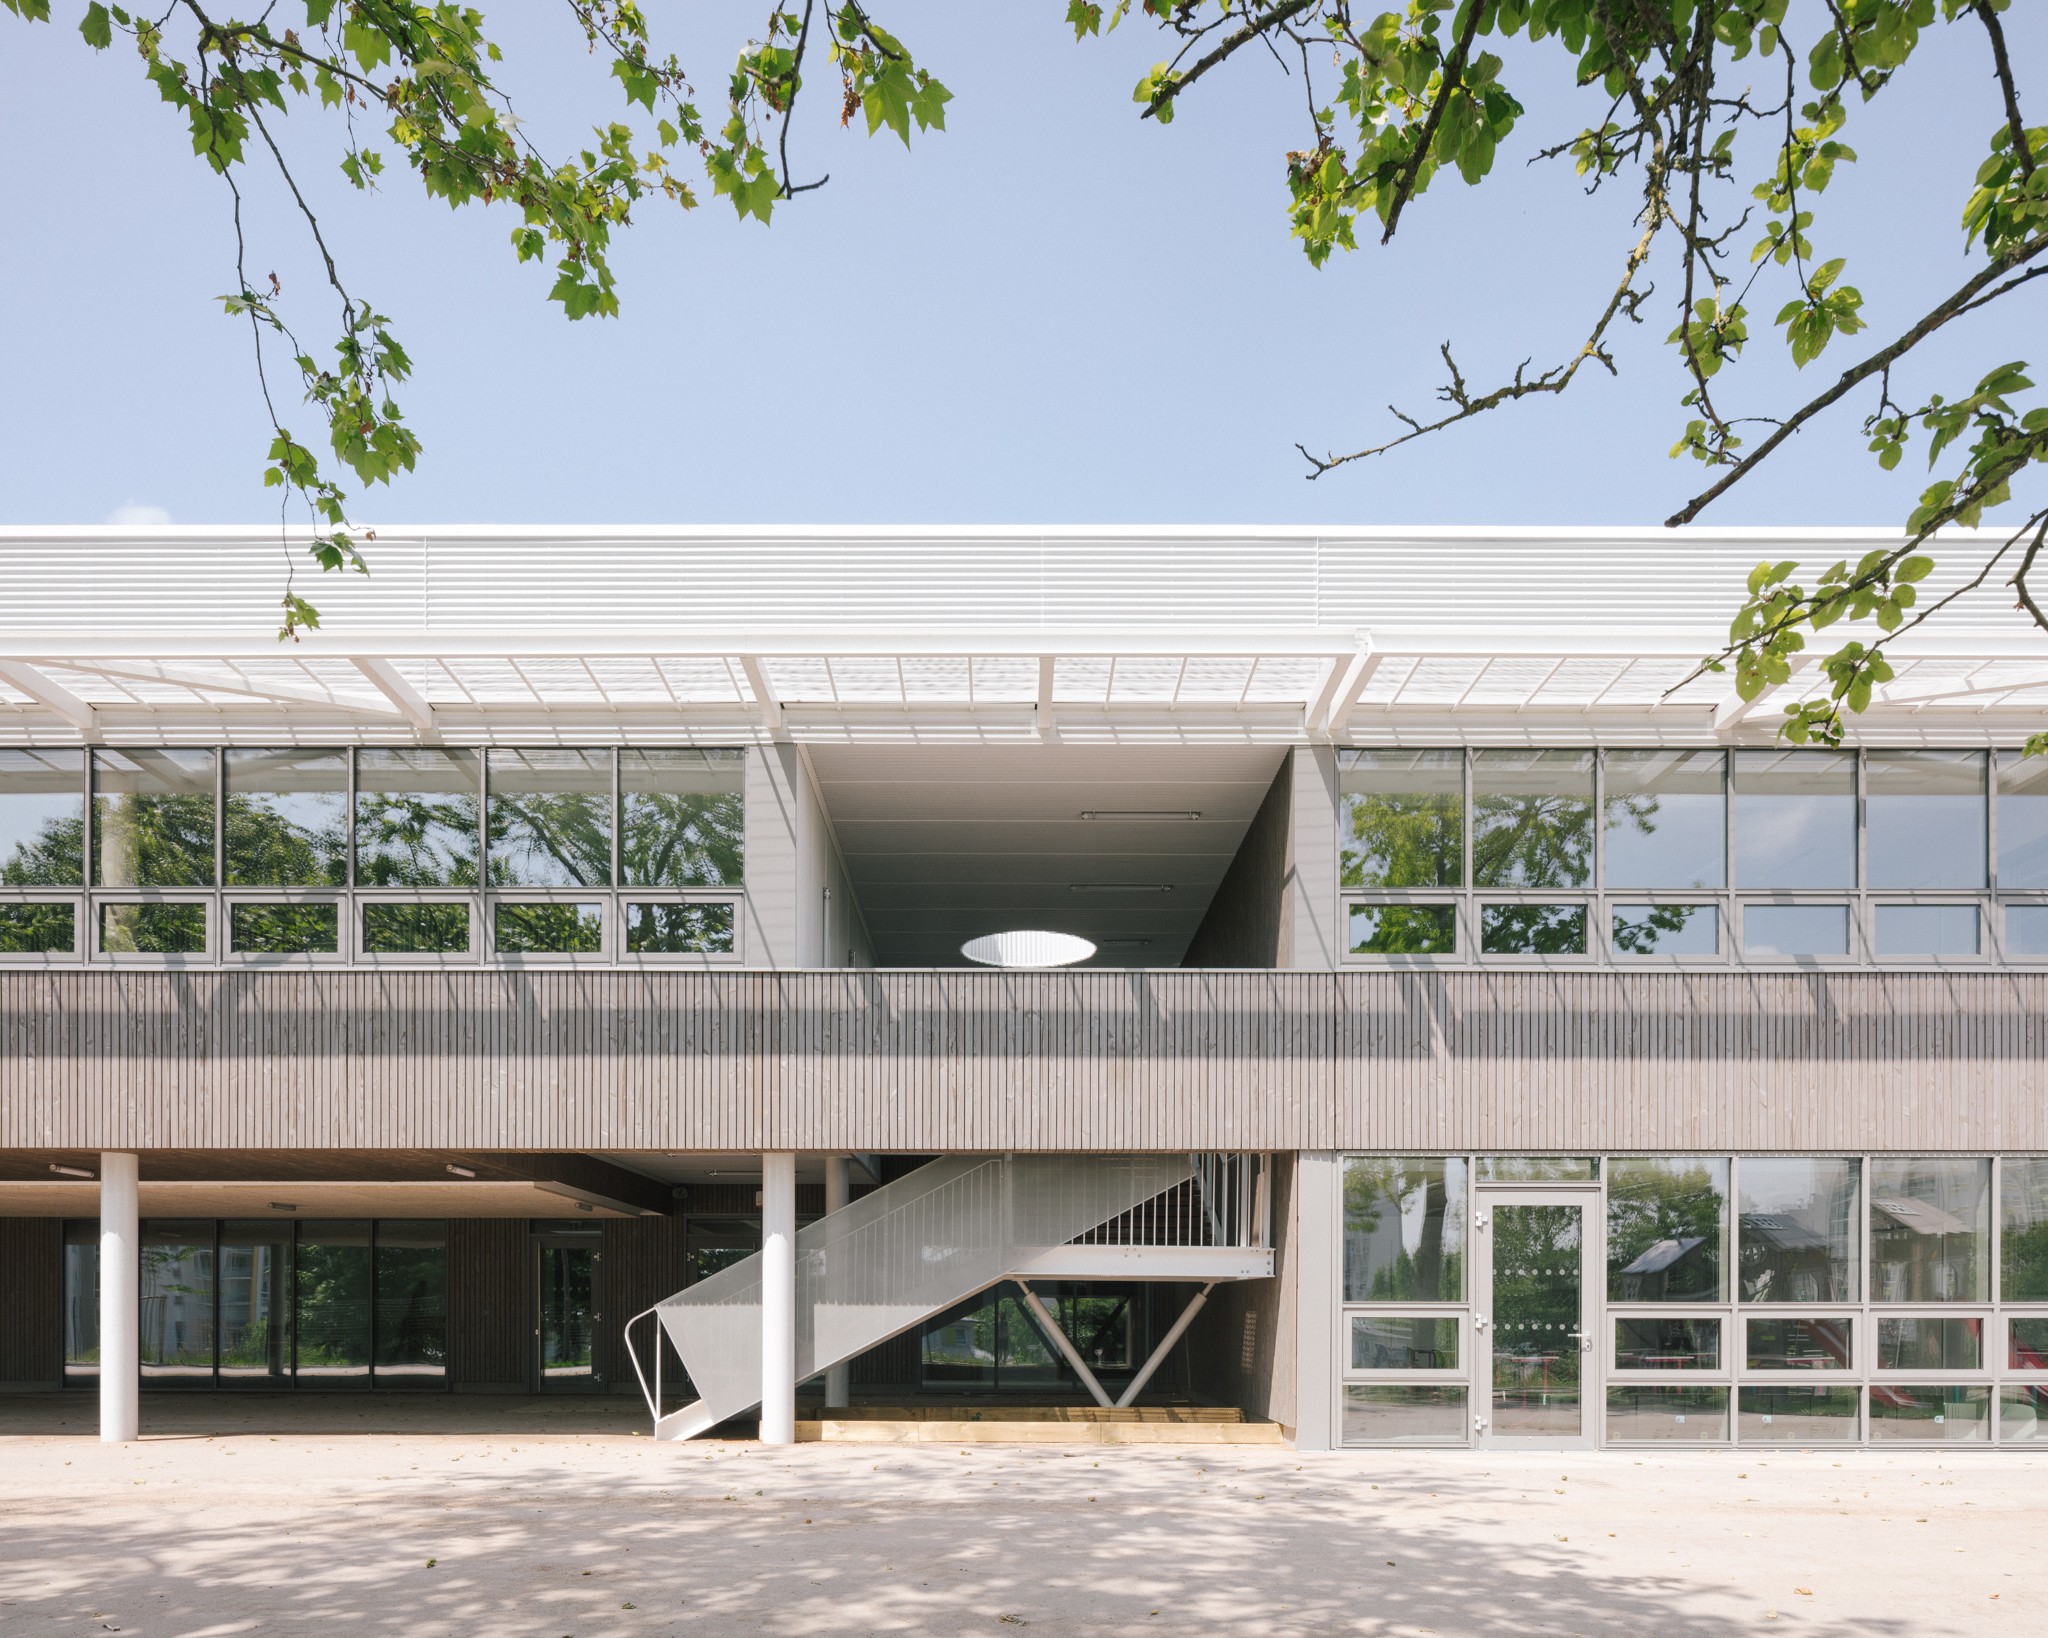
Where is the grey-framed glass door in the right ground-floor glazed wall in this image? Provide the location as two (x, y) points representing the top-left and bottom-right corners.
(1473, 1190), (1599, 1450)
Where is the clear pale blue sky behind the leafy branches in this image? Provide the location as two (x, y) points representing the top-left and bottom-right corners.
(0, 0), (2048, 526)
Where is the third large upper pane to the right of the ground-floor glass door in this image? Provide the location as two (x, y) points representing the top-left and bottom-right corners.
(1870, 1159), (1991, 1302)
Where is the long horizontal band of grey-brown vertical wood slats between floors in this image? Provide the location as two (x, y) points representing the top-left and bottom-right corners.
(0, 971), (2048, 1153)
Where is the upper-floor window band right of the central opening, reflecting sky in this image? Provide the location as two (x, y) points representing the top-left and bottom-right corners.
(1337, 747), (2048, 968)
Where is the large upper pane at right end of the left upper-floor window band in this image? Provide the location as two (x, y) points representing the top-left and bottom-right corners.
(618, 751), (748, 887)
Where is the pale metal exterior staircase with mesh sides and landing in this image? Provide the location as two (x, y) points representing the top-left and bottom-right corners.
(627, 1155), (1272, 1439)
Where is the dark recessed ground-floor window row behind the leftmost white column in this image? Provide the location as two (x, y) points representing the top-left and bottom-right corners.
(63, 1218), (449, 1388)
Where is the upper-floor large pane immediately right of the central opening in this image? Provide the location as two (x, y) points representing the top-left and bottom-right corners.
(1337, 751), (1464, 887)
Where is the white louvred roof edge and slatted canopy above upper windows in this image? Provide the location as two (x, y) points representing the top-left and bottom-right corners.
(0, 528), (2048, 743)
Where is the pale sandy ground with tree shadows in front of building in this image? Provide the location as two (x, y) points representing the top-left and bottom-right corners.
(0, 1396), (2048, 1638)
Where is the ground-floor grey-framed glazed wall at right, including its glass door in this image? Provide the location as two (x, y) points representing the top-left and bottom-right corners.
(1337, 1155), (2048, 1448)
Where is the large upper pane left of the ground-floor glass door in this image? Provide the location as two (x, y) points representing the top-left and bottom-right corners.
(1343, 1155), (1466, 1302)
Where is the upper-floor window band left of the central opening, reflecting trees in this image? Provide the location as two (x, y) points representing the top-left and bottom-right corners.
(0, 745), (748, 964)
